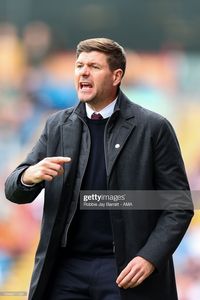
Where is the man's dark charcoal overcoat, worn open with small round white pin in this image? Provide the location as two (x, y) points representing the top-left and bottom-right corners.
(5, 91), (193, 300)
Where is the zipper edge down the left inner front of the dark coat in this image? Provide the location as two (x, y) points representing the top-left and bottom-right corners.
(61, 115), (91, 247)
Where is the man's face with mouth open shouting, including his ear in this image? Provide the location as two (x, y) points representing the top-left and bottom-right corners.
(75, 51), (122, 108)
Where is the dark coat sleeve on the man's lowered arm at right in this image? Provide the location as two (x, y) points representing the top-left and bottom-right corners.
(138, 119), (193, 270)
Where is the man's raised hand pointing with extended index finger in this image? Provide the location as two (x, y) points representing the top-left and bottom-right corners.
(22, 156), (71, 185)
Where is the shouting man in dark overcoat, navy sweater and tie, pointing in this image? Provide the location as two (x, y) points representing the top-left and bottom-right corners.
(6, 38), (193, 300)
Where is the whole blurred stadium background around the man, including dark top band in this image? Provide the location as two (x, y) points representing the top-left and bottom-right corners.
(0, 0), (200, 300)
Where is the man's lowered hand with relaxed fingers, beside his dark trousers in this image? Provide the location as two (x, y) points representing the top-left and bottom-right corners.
(116, 256), (155, 289)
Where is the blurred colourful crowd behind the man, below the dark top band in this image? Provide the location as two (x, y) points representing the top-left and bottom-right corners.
(0, 22), (200, 300)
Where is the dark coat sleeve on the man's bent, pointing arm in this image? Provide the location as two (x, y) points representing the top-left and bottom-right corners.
(5, 121), (47, 204)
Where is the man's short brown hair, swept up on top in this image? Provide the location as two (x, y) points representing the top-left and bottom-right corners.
(76, 38), (126, 75)
